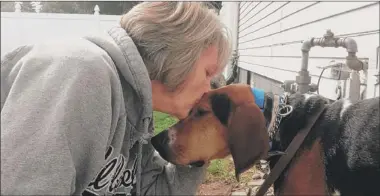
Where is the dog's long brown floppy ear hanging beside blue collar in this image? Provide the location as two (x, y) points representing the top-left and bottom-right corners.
(228, 103), (269, 181)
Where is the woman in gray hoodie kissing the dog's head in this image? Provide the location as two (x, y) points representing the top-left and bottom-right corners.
(1, 2), (231, 195)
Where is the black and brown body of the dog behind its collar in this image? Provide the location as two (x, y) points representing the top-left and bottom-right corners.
(266, 93), (380, 195)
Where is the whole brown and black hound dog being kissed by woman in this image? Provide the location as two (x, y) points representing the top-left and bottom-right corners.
(152, 84), (380, 195)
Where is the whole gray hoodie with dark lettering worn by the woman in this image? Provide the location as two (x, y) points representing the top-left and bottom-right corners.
(1, 27), (205, 195)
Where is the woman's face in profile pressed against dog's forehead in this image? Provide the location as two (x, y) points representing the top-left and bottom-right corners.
(173, 46), (220, 119)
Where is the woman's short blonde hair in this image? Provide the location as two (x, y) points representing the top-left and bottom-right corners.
(120, 1), (231, 90)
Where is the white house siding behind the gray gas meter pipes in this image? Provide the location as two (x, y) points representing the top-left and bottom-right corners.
(237, 2), (380, 99)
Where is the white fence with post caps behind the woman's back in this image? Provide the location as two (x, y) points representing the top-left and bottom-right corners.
(1, 4), (120, 56)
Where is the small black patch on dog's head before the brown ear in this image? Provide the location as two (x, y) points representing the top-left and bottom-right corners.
(211, 94), (231, 126)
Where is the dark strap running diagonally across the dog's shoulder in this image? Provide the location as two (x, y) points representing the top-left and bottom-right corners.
(256, 106), (326, 196)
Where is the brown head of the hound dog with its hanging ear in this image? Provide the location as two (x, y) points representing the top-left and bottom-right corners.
(152, 85), (269, 177)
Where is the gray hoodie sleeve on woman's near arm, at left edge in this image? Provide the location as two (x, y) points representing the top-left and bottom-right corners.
(1, 45), (117, 195)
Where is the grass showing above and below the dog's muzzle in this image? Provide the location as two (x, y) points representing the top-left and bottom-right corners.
(153, 112), (255, 183)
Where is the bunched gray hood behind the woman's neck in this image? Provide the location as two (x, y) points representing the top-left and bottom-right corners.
(85, 26), (153, 121)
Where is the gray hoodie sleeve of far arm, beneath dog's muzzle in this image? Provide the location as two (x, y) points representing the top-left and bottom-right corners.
(141, 142), (207, 195)
